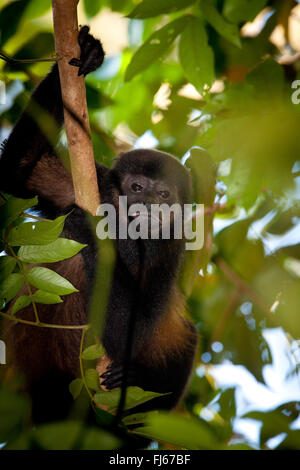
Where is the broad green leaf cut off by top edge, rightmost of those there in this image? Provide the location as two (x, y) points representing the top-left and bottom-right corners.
(223, 0), (267, 24)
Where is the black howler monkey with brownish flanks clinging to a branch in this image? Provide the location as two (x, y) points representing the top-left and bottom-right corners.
(0, 26), (197, 421)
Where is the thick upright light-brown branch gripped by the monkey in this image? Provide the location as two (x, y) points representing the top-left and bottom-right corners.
(52, 0), (100, 215)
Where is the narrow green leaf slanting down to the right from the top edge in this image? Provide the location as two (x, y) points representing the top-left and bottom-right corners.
(200, 0), (241, 47)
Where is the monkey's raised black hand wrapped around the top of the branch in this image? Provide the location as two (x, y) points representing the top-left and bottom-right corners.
(69, 26), (105, 76)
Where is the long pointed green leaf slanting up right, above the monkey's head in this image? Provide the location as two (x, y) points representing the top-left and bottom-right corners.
(125, 16), (191, 81)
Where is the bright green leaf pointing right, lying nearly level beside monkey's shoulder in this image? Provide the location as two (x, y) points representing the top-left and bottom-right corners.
(18, 238), (86, 263)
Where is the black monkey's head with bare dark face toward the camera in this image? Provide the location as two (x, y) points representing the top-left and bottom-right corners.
(113, 149), (189, 238)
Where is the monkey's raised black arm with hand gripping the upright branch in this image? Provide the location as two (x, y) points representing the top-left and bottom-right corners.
(0, 26), (104, 202)
